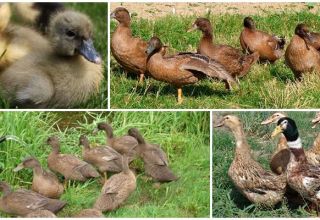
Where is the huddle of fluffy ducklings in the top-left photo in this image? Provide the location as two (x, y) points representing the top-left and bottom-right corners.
(0, 3), (103, 108)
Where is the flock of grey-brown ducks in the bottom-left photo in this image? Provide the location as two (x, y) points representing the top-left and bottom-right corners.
(0, 122), (178, 217)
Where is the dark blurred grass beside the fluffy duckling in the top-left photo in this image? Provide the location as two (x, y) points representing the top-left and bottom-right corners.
(0, 3), (108, 109)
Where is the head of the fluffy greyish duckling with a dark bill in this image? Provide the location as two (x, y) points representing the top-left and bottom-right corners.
(49, 11), (101, 64)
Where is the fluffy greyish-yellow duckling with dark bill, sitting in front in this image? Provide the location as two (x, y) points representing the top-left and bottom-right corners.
(0, 11), (103, 108)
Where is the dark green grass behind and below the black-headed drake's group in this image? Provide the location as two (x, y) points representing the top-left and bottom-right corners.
(212, 112), (319, 217)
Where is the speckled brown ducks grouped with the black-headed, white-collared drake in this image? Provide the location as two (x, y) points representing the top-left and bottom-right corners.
(215, 112), (320, 212)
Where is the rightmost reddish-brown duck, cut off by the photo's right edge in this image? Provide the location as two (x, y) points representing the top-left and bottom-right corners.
(285, 24), (320, 79)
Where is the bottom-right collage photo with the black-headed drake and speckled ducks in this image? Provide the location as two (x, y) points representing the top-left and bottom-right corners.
(212, 111), (320, 218)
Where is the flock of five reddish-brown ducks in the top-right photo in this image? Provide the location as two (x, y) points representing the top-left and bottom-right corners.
(111, 7), (320, 103)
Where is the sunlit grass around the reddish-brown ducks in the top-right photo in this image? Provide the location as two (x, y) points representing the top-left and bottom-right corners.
(110, 10), (320, 109)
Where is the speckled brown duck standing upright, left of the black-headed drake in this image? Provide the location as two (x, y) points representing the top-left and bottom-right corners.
(215, 115), (286, 206)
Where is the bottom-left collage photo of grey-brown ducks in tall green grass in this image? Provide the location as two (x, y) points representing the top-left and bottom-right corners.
(0, 111), (210, 218)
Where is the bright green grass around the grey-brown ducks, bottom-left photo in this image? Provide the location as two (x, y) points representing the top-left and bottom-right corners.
(0, 112), (210, 218)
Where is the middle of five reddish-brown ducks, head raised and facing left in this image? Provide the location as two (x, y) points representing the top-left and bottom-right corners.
(189, 18), (259, 83)
